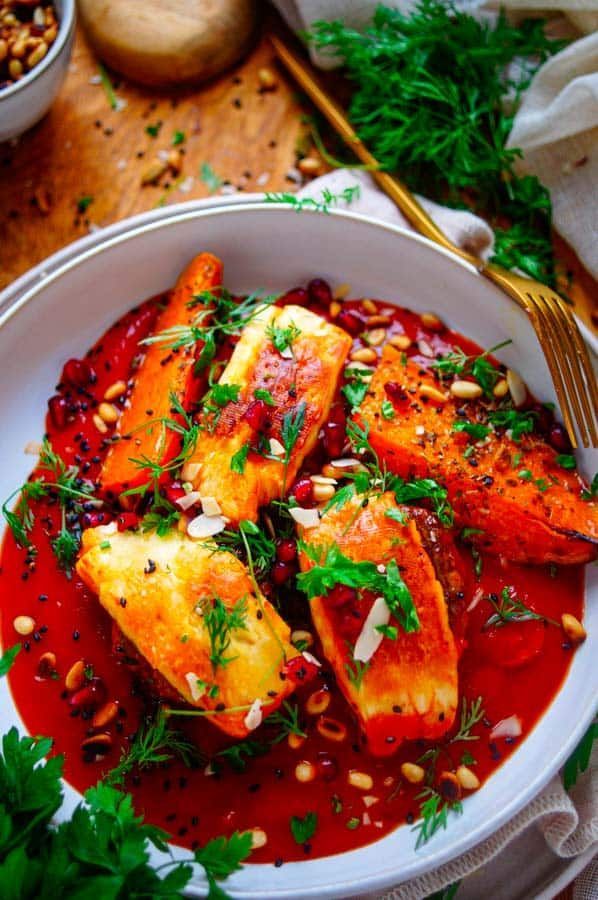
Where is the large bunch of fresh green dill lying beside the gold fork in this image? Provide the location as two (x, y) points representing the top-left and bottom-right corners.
(311, 0), (563, 285)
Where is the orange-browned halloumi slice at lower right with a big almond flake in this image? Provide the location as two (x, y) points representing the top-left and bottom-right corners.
(300, 494), (458, 756)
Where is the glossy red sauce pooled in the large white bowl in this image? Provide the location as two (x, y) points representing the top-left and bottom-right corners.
(0, 288), (583, 865)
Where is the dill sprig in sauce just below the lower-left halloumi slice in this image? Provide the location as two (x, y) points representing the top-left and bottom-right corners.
(104, 710), (202, 785)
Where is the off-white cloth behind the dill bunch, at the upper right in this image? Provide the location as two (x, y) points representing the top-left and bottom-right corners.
(274, 0), (598, 278)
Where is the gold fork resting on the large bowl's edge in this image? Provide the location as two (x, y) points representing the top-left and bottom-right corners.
(270, 35), (598, 447)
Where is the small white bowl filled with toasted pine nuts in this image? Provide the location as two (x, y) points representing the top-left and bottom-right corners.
(0, 0), (75, 142)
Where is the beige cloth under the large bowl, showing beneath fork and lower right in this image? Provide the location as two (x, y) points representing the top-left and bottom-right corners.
(299, 169), (598, 900)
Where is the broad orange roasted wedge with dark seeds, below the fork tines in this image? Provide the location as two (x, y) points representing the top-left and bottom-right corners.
(356, 347), (598, 564)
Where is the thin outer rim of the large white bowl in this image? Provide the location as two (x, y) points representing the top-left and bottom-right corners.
(0, 198), (598, 900)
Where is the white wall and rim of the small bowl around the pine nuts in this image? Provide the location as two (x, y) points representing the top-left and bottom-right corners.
(0, 0), (75, 141)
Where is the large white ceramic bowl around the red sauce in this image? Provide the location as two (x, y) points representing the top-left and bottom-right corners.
(0, 204), (598, 900)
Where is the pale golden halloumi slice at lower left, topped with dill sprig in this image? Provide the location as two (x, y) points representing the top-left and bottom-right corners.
(77, 525), (299, 738)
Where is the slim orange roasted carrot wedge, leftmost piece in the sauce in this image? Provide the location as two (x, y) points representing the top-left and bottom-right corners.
(101, 253), (222, 495)
